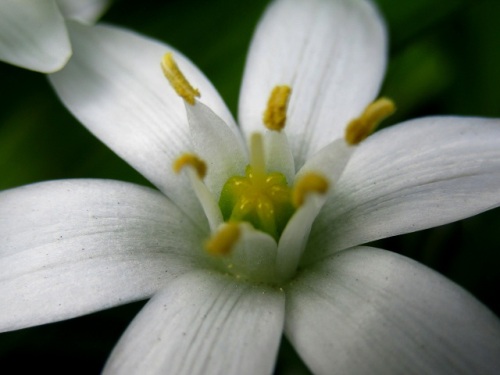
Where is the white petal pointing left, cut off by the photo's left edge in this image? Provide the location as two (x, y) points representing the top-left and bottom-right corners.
(0, 180), (203, 331)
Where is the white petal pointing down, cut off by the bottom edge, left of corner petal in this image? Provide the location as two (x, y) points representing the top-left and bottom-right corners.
(104, 272), (285, 375)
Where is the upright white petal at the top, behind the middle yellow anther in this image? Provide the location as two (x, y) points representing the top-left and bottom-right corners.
(239, 0), (386, 168)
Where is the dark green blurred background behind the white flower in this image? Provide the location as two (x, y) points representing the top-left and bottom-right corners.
(0, 0), (500, 374)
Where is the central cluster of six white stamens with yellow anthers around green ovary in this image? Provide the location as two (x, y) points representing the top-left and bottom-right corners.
(162, 53), (394, 285)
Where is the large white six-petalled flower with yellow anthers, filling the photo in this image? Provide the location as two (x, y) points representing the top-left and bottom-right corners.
(0, 0), (500, 374)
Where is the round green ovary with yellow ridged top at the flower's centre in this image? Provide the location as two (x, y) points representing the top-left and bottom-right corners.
(219, 165), (295, 241)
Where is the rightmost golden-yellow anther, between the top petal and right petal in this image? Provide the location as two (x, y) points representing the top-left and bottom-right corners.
(345, 98), (396, 145)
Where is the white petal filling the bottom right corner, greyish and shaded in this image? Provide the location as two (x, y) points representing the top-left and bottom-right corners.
(285, 248), (500, 375)
